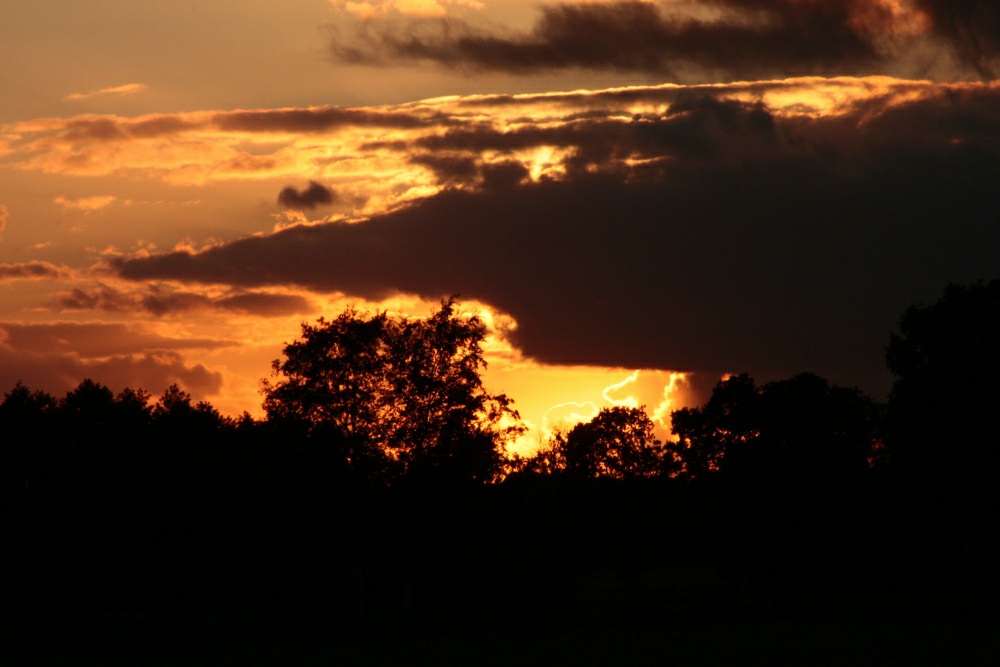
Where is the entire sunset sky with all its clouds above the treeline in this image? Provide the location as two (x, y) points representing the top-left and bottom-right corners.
(0, 0), (1000, 451)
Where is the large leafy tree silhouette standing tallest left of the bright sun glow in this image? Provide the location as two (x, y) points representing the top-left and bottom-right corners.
(263, 299), (522, 482)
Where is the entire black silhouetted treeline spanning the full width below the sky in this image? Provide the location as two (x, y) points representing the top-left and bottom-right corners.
(0, 281), (1000, 619)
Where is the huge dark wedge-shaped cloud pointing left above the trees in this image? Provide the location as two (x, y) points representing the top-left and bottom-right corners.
(116, 84), (1000, 392)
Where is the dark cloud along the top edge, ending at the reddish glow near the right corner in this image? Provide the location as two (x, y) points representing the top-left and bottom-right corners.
(332, 0), (889, 77)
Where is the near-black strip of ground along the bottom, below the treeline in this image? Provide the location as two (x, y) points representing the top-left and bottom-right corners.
(7, 582), (1000, 667)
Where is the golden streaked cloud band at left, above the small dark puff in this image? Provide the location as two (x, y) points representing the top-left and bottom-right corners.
(0, 105), (460, 187)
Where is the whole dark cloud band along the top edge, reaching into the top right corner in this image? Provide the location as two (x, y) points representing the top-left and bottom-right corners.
(331, 0), (998, 81)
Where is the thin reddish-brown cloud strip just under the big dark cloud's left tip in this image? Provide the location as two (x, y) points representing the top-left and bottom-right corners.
(54, 284), (316, 317)
